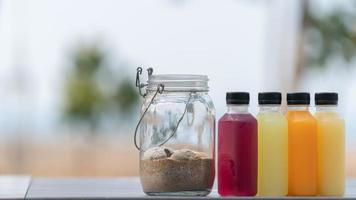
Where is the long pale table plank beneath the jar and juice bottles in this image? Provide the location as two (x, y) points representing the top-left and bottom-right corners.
(26, 177), (356, 199)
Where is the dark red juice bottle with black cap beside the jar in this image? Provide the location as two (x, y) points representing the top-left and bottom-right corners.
(218, 92), (258, 196)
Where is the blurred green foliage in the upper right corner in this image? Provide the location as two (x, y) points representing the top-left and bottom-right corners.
(303, 1), (356, 67)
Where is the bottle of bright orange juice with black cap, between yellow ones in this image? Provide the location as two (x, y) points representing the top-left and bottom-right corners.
(286, 93), (317, 196)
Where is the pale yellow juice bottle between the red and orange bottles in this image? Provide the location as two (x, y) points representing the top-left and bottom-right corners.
(257, 92), (288, 196)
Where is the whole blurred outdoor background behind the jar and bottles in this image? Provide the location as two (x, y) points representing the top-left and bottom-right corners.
(0, 0), (356, 176)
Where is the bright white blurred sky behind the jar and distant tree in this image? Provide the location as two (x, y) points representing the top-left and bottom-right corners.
(0, 0), (267, 133)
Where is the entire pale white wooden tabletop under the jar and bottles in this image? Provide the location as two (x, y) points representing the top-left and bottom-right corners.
(0, 176), (356, 199)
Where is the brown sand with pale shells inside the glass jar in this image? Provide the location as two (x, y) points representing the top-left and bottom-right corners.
(140, 147), (215, 193)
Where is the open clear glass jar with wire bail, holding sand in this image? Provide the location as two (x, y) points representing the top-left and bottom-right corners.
(135, 69), (215, 196)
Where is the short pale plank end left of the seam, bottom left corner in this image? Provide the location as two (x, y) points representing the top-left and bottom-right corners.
(0, 176), (31, 199)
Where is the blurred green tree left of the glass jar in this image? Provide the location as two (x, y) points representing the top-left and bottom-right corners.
(64, 43), (139, 133)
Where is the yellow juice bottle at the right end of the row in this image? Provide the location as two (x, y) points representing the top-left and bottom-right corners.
(315, 93), (345, 196)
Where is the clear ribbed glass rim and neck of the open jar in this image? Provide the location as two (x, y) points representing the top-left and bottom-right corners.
(147, 74), (209, 92)
